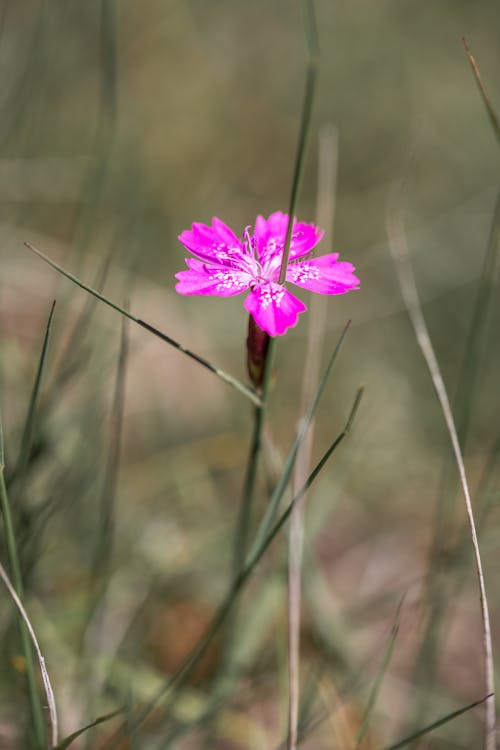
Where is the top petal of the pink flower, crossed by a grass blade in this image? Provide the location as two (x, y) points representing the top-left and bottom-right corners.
(253, 211), (324, 275)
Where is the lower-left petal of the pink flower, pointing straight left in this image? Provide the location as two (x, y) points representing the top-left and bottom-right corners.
(175, 258), (253, 297)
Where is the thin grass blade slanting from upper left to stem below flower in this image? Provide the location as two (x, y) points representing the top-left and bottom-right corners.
(24, 242), (261, 406)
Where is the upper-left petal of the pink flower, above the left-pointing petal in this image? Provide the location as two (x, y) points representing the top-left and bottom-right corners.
(179, 216), (248, 268)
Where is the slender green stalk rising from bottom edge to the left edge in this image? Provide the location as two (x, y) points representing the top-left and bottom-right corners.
(0, 420), (47, 750)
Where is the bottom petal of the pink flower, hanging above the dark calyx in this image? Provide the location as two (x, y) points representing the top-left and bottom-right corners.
(244, 281), (307, 336)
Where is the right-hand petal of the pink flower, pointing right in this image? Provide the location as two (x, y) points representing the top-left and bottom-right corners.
(286, 253), (359, 294)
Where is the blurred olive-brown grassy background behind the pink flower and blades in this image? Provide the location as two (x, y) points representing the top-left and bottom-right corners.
(0, 0), (500, 748)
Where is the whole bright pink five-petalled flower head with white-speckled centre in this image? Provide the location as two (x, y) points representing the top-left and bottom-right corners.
(175, 211), (359, 336)
